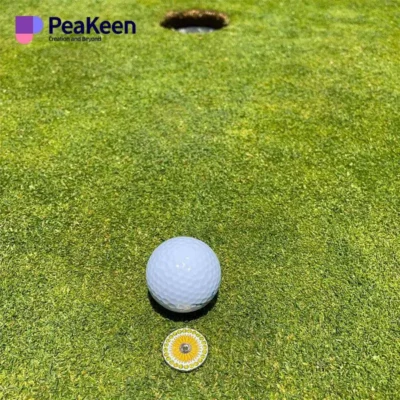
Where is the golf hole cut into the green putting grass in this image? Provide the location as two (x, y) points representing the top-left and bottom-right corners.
(161, 10), (229, 33)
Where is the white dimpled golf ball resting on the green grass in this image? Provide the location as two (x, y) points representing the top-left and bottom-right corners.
(146, 237), (221, 313)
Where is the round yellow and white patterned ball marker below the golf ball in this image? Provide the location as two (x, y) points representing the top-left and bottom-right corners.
(163, 328), (208, 371)
